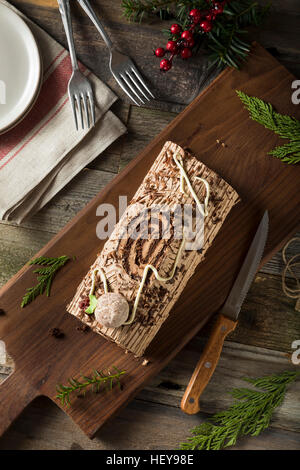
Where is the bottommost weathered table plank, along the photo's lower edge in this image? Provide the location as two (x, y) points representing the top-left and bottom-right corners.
(0, 398), (299, 451)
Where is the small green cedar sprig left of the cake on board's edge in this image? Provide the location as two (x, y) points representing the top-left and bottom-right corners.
(21, 256), (69, 308)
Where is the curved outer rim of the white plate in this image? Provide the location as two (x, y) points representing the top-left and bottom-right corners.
(0, 4), (42, 134)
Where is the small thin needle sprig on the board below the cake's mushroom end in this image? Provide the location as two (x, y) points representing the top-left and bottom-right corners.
(56, 366), (125, 407)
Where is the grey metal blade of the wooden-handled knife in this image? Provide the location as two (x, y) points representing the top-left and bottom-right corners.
(220, 211), (269, 321)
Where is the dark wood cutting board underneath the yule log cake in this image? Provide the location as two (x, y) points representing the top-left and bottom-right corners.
(0, 45), (300, 437)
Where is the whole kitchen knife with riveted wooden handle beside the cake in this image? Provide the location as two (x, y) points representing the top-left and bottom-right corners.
(181, 211), (269, 414)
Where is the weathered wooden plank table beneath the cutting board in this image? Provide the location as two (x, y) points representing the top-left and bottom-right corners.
(0, 0), (300, 450)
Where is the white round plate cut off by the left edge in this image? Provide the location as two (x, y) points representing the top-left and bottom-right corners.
(0, 5), (41, 133)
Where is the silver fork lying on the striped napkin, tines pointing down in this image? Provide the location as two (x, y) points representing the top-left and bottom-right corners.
(57, 0), (95, 130)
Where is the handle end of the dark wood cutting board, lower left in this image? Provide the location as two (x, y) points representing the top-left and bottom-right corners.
(0, 371), (40, 436)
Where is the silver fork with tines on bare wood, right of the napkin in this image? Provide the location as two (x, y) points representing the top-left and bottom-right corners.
(77, 0), (155, 106)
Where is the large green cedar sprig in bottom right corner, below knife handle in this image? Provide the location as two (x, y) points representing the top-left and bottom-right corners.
(180, 371), (300, 450)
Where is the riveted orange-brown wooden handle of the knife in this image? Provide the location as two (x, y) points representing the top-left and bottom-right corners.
(181, 314), (237, 415)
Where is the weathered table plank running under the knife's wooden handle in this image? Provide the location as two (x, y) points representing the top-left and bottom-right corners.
(139, 338), (300, 432)
